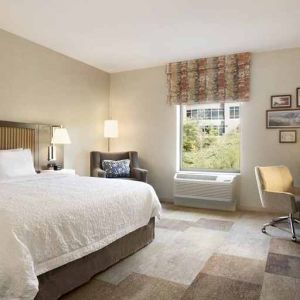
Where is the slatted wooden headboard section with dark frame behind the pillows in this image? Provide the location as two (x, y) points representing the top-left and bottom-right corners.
(0, 121), (39, 168)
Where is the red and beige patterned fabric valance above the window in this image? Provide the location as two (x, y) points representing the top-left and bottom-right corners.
(166, 53), (251, 104)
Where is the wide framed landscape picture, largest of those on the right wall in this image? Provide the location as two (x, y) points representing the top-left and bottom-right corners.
(266, 109), (300, 128)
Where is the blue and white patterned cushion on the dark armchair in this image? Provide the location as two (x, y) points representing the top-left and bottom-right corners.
(102, 159), (130, 178)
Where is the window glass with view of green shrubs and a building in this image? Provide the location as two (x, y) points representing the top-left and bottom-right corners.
(180, 103), (240, 172)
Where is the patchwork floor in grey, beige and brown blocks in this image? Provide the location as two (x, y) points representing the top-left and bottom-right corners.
(63, 205), (300, 300)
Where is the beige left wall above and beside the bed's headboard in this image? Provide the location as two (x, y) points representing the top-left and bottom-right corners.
(0, 30), (110, 175)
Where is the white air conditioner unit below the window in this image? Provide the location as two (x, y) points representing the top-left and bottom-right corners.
(174, 172), (238, 210)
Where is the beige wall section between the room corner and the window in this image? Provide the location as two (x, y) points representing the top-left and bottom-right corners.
(110, 67), (176, 198)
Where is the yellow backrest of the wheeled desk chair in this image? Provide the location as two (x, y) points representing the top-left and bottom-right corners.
(255, 166), (293, 207)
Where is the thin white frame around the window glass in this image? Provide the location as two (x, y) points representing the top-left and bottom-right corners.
(178, 103), (241, 174)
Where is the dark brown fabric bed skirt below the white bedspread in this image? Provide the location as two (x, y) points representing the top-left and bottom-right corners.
(35, 218), (155, 300)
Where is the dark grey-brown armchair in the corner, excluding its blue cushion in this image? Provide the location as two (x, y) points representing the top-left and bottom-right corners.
(90, 151), (148, 182)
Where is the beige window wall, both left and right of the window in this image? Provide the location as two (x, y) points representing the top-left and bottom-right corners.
(110, 48), (300, 210)
